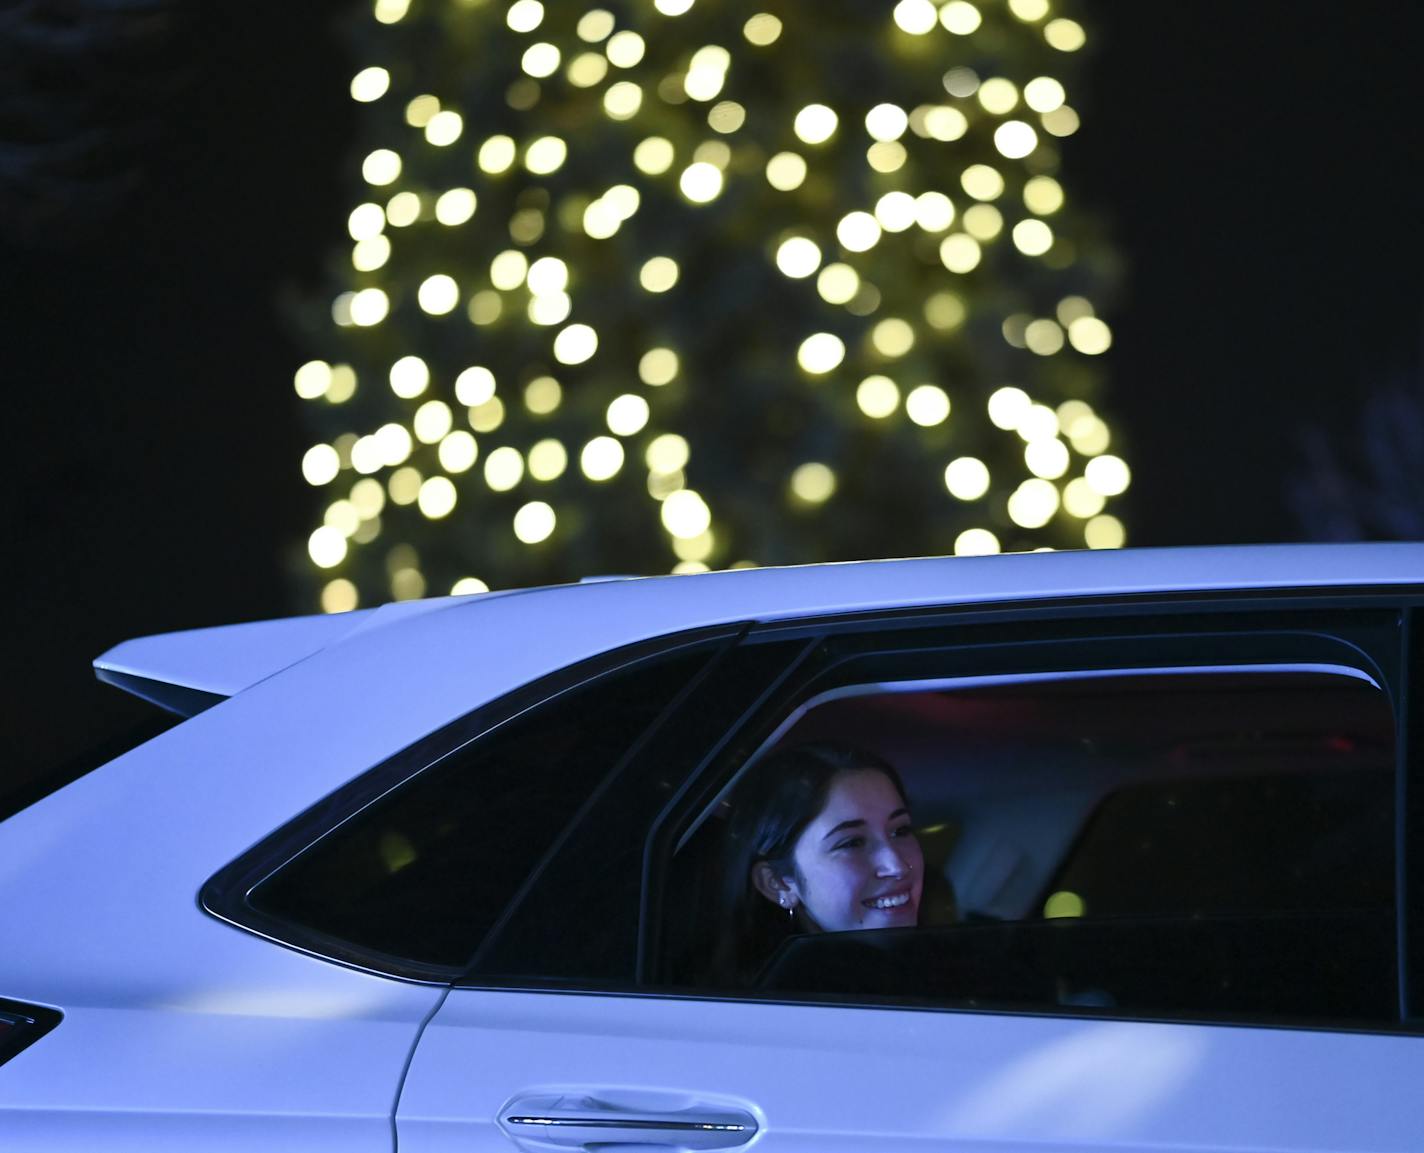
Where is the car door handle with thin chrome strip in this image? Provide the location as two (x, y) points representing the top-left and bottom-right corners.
(500, 1095), (756, 1150)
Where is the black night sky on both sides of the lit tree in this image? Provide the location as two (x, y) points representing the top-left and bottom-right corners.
(8, 0), (1424, 780)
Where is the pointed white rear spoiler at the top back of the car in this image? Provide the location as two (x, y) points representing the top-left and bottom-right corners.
(94, 594), (467, 716)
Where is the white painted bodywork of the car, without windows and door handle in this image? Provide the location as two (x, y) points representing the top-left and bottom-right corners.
(0, 545), (1424, 1153)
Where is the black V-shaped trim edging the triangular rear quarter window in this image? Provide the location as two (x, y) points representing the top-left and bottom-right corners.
(198, 622), (748, 985)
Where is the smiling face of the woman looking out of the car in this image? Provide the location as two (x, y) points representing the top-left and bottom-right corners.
(785, 769), (924, 932)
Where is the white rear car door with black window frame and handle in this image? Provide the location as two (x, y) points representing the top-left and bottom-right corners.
(396, 596), (1424, 1153)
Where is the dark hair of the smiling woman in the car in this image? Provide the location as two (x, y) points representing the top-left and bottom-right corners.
(715, 742), (910, 985)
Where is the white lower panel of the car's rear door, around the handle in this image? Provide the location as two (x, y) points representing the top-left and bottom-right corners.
(397, 989), (1424, 1153)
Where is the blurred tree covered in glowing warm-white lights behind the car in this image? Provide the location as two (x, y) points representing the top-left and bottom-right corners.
(296, 0), (1128, 609)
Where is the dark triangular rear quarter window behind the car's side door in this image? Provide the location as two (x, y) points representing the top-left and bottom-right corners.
(248, 649), (706, 967)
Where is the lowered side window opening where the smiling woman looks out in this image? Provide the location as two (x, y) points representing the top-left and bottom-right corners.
(658, 637), (1400, 1025)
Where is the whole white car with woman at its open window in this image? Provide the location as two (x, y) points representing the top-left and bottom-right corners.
(0, 544), (1424, 1153)
